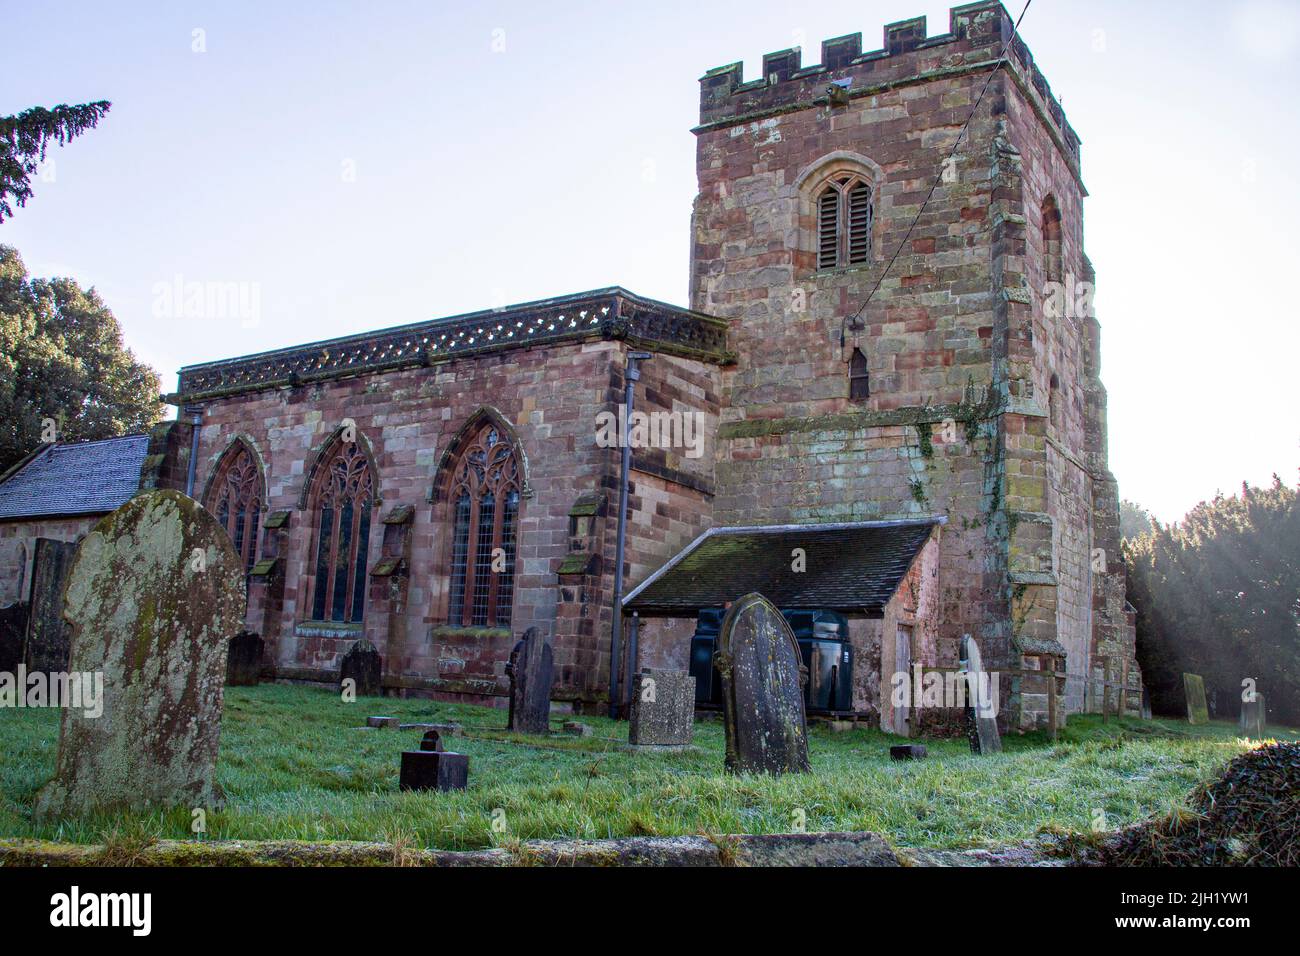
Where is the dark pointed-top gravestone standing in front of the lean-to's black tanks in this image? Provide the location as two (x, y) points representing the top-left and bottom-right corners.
(714, 594), (809, 774)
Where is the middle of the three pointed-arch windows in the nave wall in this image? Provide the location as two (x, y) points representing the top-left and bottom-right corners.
(312, 441), (374, 623)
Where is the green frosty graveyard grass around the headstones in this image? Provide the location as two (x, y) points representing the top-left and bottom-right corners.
(0, 685), (1296, 849)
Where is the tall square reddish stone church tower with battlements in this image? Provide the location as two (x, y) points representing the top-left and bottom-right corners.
(690, 3), (1140, 724)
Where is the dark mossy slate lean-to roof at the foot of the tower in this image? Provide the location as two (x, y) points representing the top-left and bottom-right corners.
(623, 518), (946, 617)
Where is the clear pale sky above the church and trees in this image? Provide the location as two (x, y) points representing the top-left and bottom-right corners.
(0, 0), (1300, 520)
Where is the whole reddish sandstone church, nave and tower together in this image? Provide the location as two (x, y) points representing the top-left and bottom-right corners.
(0, 3), (1141, 734)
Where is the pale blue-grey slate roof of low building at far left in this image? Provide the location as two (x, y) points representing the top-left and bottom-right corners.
(0, 434), (150, 520)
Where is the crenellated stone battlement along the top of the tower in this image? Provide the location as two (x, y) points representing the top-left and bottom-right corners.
(697, 0), (1079, 166)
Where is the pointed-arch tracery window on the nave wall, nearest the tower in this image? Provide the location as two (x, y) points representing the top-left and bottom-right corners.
(447, 423), (520, 627)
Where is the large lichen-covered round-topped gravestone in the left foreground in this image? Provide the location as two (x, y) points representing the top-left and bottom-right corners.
(36, 490), (244, 817)
